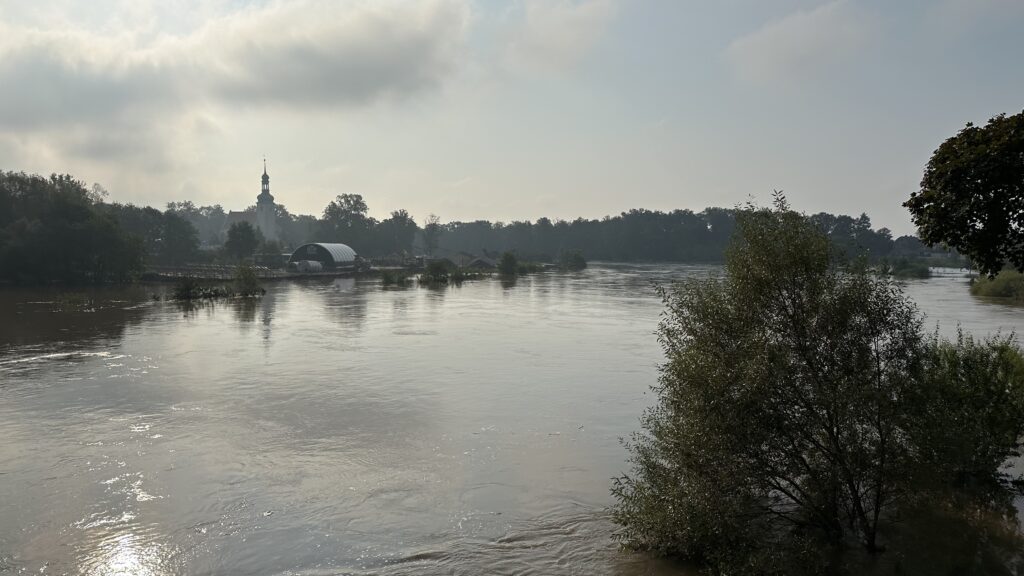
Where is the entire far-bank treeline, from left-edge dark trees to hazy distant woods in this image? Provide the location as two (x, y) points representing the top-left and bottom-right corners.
(0, 172), (954, 283)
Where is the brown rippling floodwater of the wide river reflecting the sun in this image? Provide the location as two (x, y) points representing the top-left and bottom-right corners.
(0, 264), (1024, 575)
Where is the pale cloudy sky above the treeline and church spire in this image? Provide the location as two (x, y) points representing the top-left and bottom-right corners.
(0, 0), (1024, 234)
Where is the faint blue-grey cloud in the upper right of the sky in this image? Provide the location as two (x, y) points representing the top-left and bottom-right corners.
(725, 0), (876, 87)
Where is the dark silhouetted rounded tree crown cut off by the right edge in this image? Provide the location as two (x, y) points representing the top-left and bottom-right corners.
(903, 112), (1024, 276)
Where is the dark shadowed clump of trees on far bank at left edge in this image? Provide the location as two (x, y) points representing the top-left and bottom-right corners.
(0, 172), (144, 283)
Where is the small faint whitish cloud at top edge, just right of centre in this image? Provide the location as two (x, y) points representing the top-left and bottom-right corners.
(508, 0), (617, 70)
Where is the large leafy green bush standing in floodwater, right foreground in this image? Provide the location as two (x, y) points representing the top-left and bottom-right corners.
(612, 199), (1024, 574)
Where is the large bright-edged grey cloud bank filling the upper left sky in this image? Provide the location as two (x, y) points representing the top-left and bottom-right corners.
(0, 0), (469, 163)
